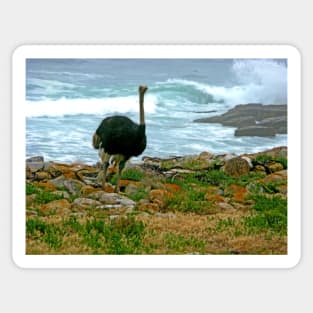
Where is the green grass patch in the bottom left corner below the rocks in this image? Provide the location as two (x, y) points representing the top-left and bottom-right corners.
(26, 216), (145, 254)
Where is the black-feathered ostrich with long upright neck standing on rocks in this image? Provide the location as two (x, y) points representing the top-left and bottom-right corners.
(92, 86), (148, 192)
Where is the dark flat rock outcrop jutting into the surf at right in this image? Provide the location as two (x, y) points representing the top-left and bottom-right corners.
(194, 103), (287, 137)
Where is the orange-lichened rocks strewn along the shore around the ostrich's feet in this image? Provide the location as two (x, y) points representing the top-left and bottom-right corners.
(26, 147), (287, 214)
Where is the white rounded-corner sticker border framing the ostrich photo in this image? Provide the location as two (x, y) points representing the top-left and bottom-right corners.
(12, 45), (301, 269)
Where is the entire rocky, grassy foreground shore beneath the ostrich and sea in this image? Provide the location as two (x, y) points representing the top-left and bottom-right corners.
(26, 147), (288, 254)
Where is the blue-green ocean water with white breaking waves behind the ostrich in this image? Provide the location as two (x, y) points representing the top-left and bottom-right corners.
(25, 59), (287, 164)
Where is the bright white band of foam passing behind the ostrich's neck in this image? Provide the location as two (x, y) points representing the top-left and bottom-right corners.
(26, 95), (157, 117)
